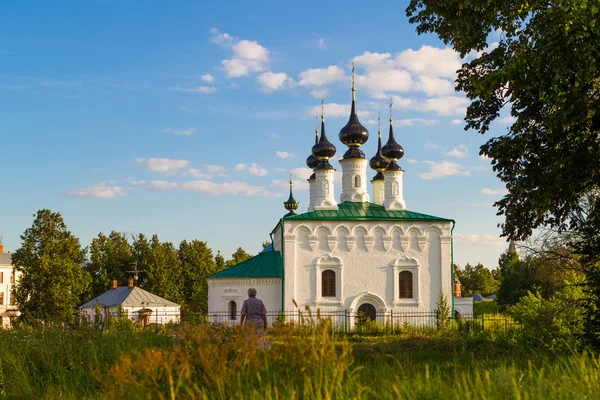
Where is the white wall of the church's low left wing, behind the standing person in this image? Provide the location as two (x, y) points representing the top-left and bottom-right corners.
(207, 278), (281, 323)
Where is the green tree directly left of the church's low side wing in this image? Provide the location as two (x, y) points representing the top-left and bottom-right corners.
(178, 240), (217, 313)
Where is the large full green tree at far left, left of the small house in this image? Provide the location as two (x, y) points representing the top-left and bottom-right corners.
(12, 209), (90, 323)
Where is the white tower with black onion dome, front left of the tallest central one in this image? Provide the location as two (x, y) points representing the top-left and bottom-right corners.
(312, 99), (338, 210)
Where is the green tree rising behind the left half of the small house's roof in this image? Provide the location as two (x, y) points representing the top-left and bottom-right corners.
(85, 231), (134, 296)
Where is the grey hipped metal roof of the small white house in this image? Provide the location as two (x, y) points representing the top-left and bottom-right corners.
(79, 286), (179, 308)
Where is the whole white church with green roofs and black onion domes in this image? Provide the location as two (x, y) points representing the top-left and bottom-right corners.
(208, 75), (473, 322)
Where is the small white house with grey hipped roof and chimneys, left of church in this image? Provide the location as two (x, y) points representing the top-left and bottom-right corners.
(79, 278), (181, 326)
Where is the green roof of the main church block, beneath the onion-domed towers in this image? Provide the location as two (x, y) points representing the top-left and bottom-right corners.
(283, 201), (453, 222)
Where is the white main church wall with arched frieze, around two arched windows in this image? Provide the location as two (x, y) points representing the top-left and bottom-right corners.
(284, 221), (452, 311)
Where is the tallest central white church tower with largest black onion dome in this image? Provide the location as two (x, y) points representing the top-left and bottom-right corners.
(339, 63), (369, 202)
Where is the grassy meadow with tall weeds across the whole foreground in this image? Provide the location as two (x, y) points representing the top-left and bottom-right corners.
(0, 324), (600, 399)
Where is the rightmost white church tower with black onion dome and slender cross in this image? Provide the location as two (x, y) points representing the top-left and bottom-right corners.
(381, 99), (406, 210)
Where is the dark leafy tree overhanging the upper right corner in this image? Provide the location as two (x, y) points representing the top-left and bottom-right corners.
(406, 0), (600, 346)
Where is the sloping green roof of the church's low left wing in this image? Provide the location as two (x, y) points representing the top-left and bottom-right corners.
(208, 250), (283, 279)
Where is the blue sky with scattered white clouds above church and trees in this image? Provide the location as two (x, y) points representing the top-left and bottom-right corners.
(0, 1), (509, 268)
